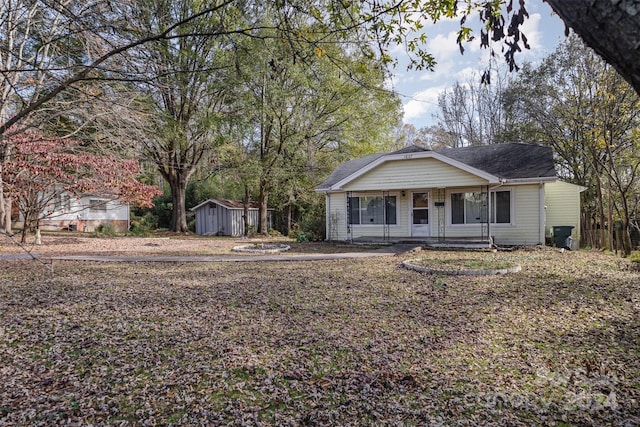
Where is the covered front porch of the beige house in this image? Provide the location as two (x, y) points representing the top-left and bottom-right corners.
(327, 185), (508, 248)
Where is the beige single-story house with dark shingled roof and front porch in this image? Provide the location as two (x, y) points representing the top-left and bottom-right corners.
(316, 143), (584, 247)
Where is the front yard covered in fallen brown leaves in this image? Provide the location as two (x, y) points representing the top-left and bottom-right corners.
(0, 242), (640, 426)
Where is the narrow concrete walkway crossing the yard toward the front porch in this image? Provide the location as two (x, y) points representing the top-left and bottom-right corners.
(0, 244), (419, 263)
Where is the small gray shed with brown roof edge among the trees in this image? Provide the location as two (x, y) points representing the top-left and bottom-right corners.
(191, 199), (272, 237)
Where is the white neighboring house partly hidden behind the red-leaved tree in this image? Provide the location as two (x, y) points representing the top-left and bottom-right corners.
(39, 193), (130, 233)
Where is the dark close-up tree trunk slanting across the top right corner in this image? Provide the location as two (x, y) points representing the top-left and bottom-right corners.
(545, 0), (640, 94)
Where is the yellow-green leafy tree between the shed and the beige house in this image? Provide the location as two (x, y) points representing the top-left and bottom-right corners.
(228, 15), (399, 234)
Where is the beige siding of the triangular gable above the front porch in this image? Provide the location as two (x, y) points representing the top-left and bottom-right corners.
(344, 158), (487, 191)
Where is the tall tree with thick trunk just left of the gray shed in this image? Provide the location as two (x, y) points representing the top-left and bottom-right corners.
(122, 0), (235, 232)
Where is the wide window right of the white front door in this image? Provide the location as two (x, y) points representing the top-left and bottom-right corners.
(451, 190), (512, 225)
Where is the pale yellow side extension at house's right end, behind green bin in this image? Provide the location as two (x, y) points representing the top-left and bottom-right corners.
(545, 181), (581, 244)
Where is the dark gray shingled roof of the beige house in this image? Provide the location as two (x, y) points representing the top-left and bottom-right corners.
(318, 143), (556, 190)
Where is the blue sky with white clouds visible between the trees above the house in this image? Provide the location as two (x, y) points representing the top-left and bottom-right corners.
(391, 0), (564, 128)
